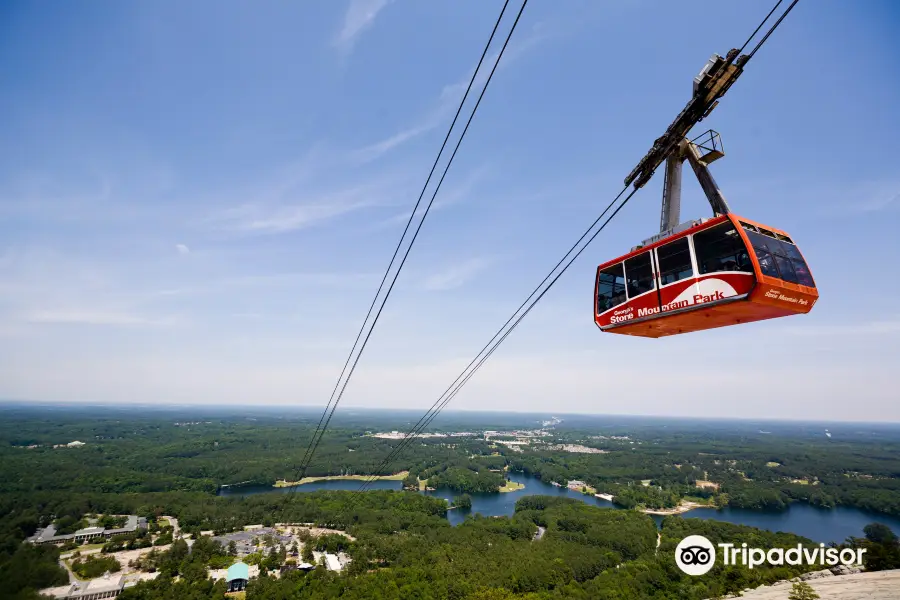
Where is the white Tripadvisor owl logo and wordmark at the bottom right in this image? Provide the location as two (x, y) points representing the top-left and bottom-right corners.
(675, 535), (865, 575)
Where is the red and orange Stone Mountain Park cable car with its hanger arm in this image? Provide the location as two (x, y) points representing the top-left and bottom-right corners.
(594, 130), (819, 338)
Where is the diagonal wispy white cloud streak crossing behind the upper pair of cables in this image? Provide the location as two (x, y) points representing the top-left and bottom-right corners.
(352, 23), (551, 163)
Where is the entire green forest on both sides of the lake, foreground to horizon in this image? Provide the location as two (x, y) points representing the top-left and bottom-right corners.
(0, 410), (900, 600)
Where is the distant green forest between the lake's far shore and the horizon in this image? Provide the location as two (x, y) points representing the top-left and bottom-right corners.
(0, 415), (900, 525)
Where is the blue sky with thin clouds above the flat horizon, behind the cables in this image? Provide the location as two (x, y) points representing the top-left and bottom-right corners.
(0, 0), (900, 421)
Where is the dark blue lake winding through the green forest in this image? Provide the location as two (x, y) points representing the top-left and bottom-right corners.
(219, 473), (900, 543)
